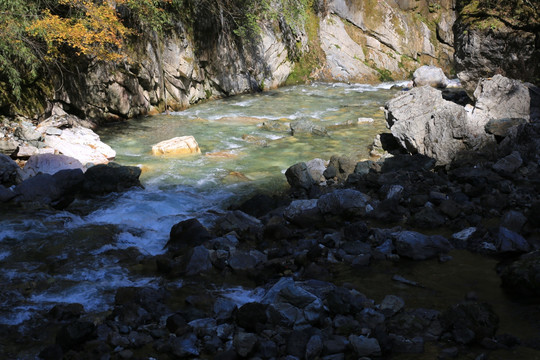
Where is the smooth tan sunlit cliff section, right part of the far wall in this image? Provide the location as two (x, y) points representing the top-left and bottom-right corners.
(314, 0), (455, 81)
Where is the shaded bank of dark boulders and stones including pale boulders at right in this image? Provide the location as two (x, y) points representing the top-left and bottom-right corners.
(0, 74), (540, 359)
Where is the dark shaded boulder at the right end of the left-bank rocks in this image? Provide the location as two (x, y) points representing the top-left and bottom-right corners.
(83, 163), (142, 195)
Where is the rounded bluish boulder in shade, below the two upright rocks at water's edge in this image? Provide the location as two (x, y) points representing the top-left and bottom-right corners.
(317, 189), (369, 216)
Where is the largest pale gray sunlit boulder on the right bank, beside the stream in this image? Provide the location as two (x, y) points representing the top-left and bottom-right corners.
(385, 86), (494, 165)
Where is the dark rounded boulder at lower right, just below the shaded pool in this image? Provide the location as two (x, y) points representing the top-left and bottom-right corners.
(441, 302), (499, 344)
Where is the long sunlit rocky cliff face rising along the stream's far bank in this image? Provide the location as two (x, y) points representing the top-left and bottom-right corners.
(34, 0), (455, 122)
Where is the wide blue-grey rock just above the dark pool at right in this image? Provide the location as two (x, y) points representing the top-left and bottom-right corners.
(394, 231), (452, 260)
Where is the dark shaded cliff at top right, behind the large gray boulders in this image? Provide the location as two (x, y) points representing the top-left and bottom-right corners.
(454, 0), (540, 93)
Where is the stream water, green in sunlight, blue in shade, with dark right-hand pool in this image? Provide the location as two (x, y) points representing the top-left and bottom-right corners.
(0, 83), (539, 358)
